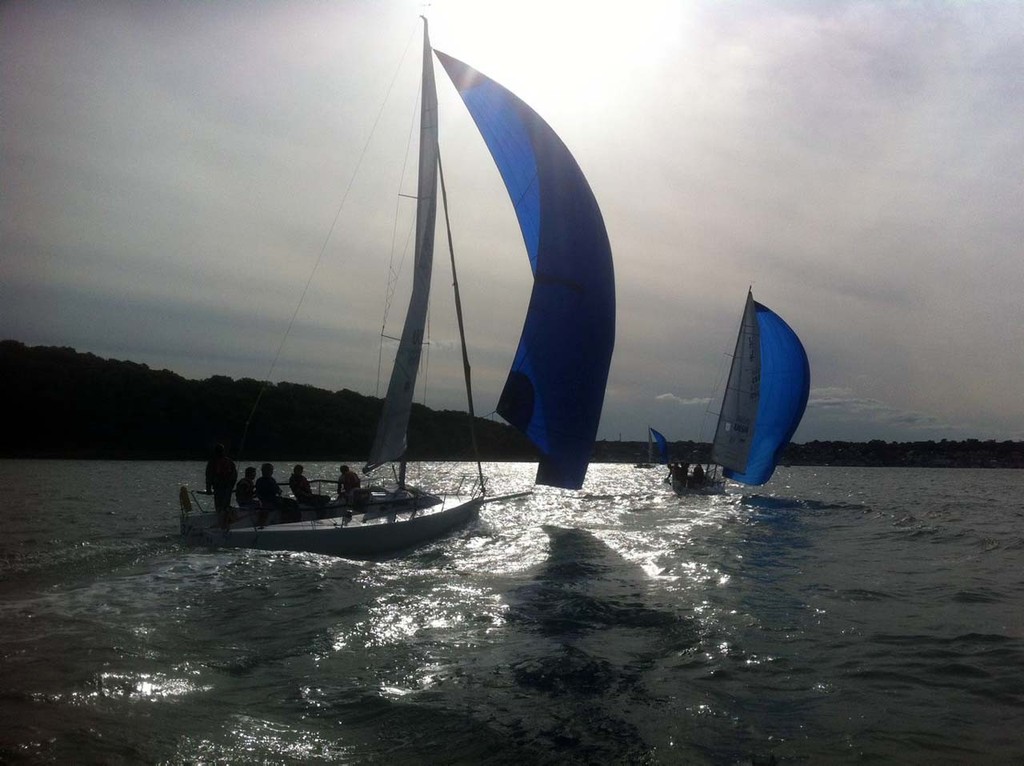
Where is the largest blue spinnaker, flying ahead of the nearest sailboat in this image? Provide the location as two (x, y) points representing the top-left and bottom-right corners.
(434, 50), (615, 490)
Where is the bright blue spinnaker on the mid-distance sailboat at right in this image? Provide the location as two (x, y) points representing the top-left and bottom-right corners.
(723, 301), (811, 484)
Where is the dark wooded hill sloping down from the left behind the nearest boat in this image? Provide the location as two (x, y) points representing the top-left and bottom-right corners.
(0, 340), (536, 461)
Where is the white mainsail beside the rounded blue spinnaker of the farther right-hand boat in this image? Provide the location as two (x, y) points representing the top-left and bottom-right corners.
(711, 291), (761, 473)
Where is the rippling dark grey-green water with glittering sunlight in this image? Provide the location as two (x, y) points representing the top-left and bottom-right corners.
(0, 461), (1024, 766)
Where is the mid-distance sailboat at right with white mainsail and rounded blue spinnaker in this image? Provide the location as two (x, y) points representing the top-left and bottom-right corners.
(672, 290), (811, 495)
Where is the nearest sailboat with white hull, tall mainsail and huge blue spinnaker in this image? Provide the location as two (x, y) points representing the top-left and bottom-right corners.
(181, 18), (615, 558)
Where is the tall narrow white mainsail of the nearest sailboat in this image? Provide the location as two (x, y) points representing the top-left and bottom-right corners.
(364, 24), (438, 471)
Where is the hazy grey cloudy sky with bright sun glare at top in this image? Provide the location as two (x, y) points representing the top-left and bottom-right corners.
(0, 0), (1024, 442)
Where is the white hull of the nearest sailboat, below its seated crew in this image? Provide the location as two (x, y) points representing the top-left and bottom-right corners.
(181, 496), (484, 558)
